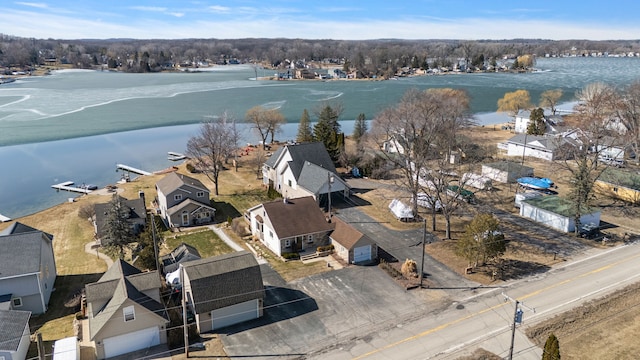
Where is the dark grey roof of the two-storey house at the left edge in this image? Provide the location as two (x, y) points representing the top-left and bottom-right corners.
(0, 223), (53, 278)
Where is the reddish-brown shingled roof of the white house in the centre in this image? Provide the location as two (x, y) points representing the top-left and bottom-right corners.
(262, 196), (333, 239)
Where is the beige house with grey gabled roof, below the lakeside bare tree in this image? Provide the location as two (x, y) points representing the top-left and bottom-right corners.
(156, 172), (216, 227)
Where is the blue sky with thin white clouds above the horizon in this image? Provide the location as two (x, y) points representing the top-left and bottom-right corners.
(0, 0), (640, 40)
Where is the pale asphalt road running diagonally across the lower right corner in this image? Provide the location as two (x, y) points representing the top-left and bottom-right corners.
(307, 240), (640, 360)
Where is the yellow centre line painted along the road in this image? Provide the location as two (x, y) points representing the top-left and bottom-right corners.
(353, 249), (640, 360)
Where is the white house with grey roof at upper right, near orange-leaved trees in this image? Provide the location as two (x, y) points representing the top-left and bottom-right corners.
(507, 134), (580, 161)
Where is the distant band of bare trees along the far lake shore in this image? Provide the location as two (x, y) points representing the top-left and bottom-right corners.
(0, 34), (640, 77)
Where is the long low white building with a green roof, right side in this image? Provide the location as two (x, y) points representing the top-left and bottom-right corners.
(520, 196), (600, 232)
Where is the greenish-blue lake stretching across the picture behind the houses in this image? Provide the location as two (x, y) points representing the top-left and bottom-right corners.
(0, 58), (640, 218)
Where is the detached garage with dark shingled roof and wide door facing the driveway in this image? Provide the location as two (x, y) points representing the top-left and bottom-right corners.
(180, 251), (265, 333)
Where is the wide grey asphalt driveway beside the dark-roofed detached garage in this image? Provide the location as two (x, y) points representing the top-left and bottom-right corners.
(220, 265), (440, 359)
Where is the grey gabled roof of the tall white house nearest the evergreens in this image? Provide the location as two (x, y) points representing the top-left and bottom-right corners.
(265, 142), (336, 180)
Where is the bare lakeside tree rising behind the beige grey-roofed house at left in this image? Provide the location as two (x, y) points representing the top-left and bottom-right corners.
(186, 112), (238, 195)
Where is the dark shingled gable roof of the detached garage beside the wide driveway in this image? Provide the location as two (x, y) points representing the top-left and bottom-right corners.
(182, 251), (264, 314)
